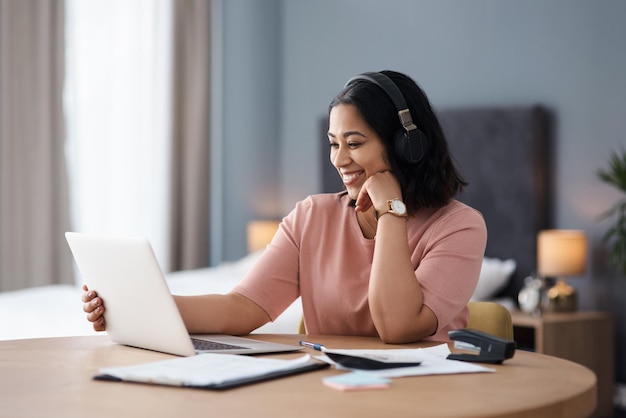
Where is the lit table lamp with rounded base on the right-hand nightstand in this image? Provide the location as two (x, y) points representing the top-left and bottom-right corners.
(537, 229), (587, 312)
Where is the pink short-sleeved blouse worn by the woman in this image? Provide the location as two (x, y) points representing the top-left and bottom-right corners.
(234, 193), (487, 341)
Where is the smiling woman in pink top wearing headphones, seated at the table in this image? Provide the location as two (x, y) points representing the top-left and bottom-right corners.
(82, 71), (486, 343)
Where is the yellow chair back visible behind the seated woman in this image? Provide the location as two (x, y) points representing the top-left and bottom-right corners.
(298, 302), (513, 340)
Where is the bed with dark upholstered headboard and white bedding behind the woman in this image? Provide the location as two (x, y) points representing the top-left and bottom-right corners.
(0, 106), (551, 340)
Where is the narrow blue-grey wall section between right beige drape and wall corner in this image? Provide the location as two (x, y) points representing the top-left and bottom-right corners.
(210, 0), (282, 264)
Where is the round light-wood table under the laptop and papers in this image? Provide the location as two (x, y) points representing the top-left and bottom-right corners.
(0, 334), (596, 418)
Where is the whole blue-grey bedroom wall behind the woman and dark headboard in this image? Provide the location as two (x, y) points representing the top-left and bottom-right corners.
(212, 0), (626, 381)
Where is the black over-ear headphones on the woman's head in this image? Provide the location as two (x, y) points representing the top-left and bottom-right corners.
(344, 72), (428, 164)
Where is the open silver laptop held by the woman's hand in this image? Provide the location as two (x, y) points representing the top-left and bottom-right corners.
(65, 232), (302, 356)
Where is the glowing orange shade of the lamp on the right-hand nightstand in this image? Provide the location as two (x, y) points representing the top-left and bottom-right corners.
(537, 229), (587, 277)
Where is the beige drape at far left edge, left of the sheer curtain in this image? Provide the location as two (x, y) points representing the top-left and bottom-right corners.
(0, 0), (73, 291)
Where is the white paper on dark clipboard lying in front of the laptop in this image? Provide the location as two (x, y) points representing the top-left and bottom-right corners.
(95, 353), (327, 389)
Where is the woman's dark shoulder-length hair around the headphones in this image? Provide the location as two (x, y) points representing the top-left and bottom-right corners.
(328, 71), (467, 215)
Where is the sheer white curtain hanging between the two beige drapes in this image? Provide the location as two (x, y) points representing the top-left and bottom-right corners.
(65, 0), (173, 271)
